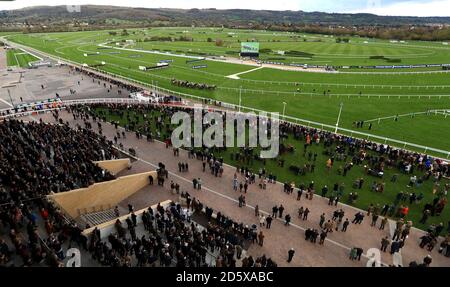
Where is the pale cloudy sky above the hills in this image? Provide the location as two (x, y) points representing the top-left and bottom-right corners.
(0, 0), (450, 16)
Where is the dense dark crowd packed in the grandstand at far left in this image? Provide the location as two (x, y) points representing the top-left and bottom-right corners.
(0, 113), (119, 266)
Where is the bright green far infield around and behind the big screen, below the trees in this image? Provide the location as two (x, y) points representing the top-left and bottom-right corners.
(108, 28), (450, 66)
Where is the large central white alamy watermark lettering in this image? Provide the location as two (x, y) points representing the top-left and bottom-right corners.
(171, 106), (280, 158)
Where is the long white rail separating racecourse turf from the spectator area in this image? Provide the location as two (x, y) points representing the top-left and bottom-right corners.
(5, 38), (450, 160)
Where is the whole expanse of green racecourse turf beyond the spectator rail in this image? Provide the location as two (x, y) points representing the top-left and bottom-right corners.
(4, 28), (450, 157)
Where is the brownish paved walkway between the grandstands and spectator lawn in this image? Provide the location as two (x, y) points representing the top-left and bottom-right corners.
(25, 111), (450, 266)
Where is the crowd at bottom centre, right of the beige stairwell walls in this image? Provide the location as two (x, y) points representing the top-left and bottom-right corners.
(84, 201), (276, 267)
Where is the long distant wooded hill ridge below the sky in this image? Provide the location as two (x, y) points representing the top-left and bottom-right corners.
(0, 5), (450, 27)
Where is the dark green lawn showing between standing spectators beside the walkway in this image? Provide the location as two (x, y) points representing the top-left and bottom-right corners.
(90, 108), (450, 233)
